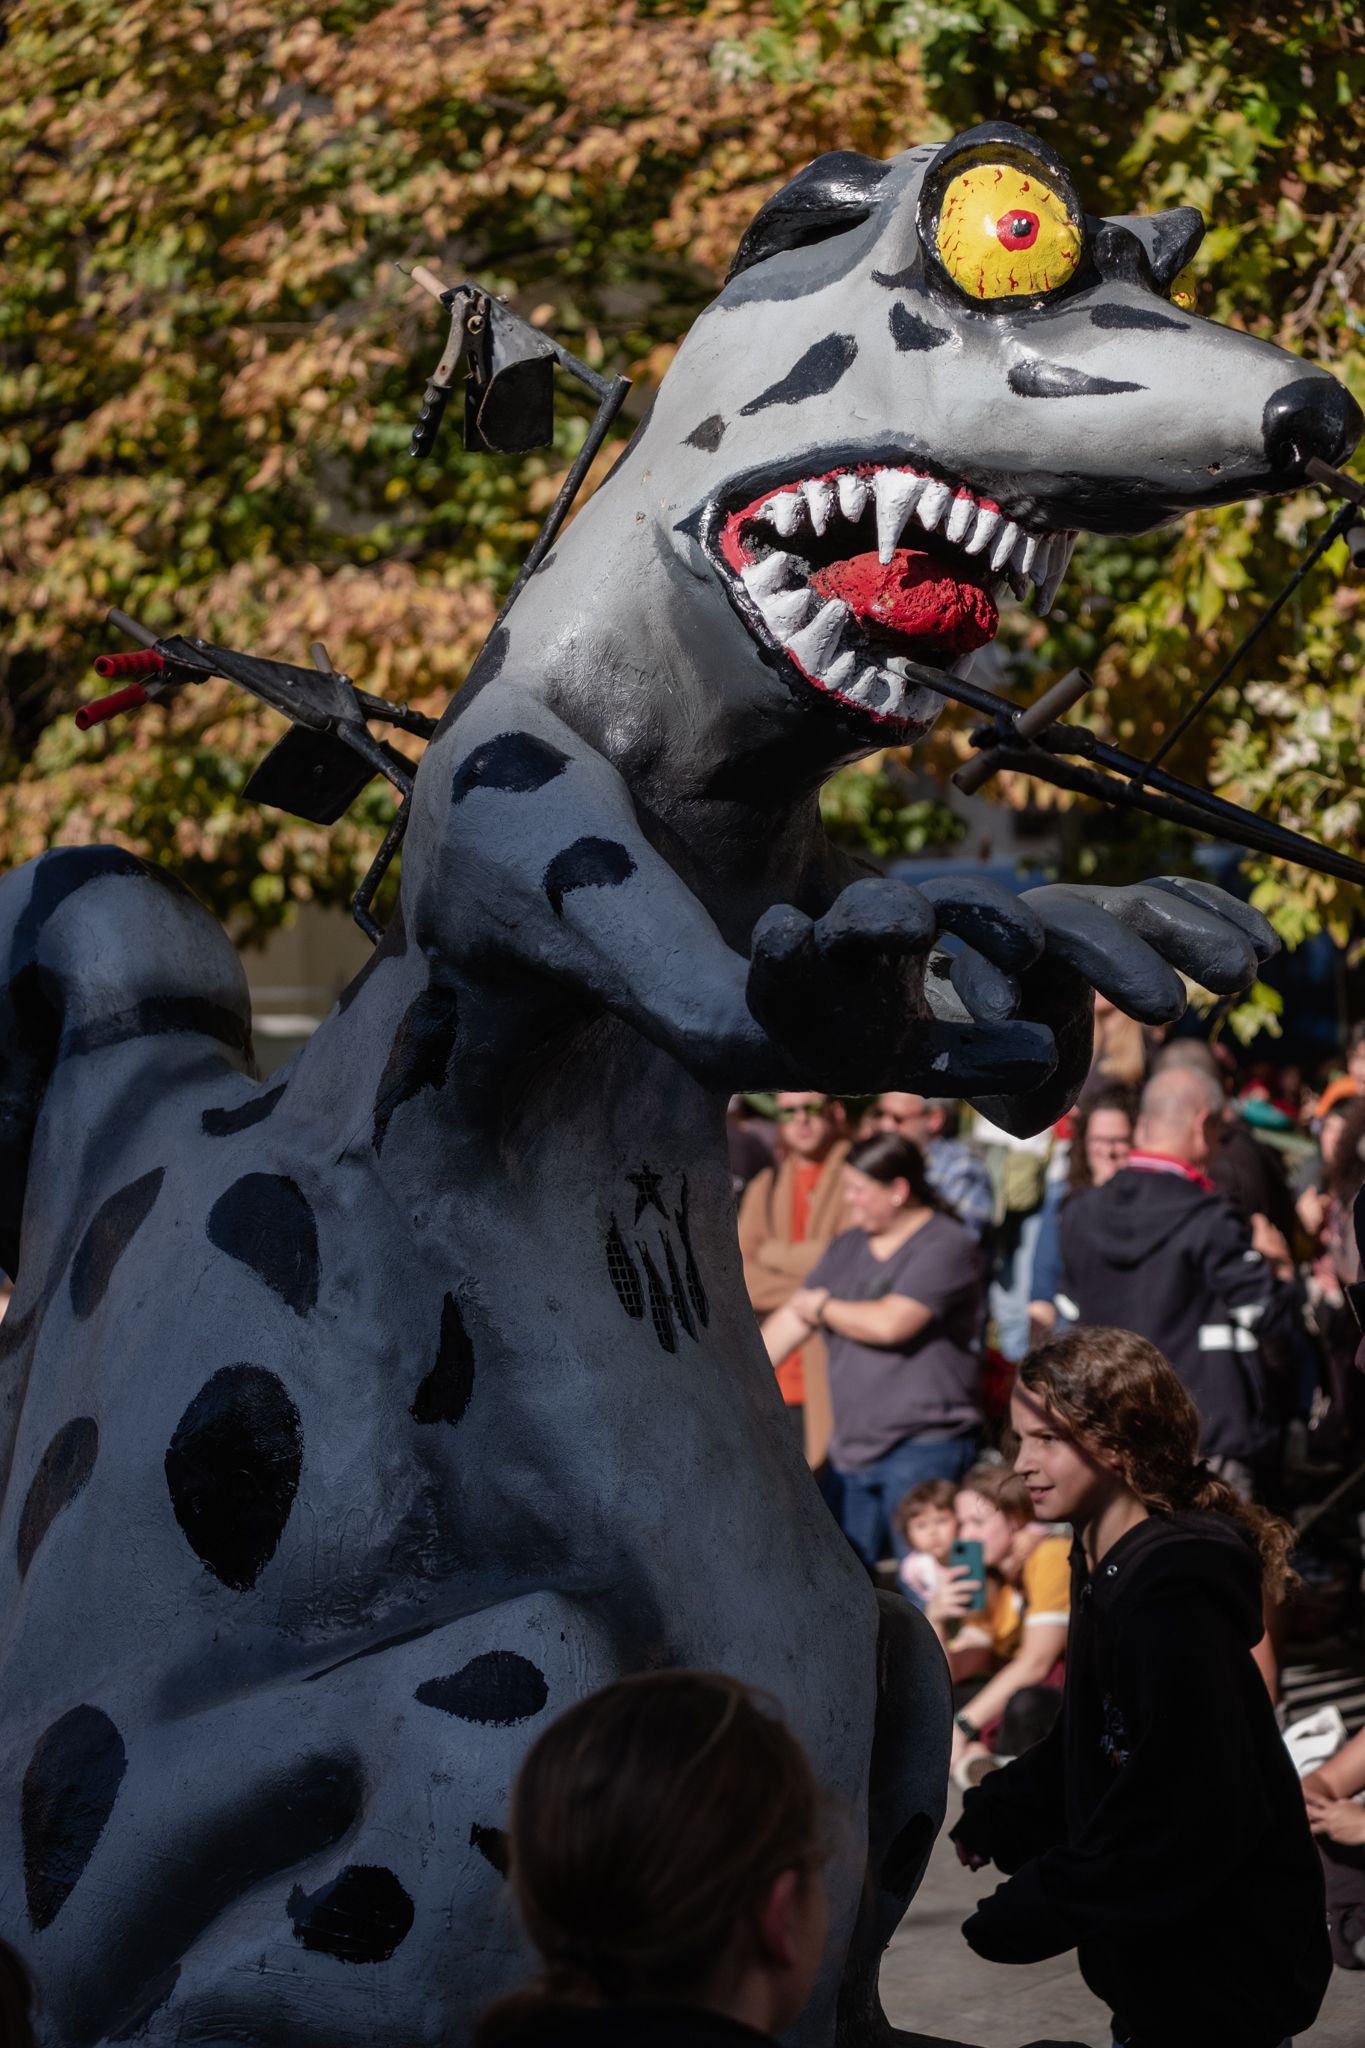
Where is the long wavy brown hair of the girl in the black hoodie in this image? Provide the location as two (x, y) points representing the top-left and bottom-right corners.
(1019, 1325), (1297, 1597)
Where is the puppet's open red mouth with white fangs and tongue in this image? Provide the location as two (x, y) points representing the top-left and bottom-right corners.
(718, 463), (1076, 723)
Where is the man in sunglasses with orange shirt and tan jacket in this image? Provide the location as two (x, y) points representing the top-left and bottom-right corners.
(739, 1090), (849, 1466)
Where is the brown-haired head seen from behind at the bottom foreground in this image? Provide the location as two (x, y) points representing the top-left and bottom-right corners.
(477, 1671), (825, 2048)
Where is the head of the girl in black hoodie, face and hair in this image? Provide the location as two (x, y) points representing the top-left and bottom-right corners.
(1009, 1325), (1293, 1593)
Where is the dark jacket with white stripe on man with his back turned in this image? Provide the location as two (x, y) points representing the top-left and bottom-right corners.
(1060, 1167), (1295, 1464)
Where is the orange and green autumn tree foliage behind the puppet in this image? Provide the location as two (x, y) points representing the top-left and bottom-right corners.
(0, 0), (1365, 958)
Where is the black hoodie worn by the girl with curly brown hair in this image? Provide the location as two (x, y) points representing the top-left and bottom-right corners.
(954, 1513), (1332, 2048)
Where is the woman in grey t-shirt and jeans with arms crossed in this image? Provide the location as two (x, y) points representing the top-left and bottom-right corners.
(763, 1135), (984, 1567)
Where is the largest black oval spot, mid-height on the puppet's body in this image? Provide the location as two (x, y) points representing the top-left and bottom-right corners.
(166, 1366), (303, 1593)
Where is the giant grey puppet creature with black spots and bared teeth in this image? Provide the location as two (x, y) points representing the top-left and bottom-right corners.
(0, 127), (1359, 2048)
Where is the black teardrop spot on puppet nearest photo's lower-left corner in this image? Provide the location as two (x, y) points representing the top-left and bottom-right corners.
(20, 1706), (127, 1933)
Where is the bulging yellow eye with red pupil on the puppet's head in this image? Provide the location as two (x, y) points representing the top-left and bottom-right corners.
(937, 164), (1081, 299)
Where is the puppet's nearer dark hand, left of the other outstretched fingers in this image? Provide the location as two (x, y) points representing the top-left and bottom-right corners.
(749, 877), (1056, 1094)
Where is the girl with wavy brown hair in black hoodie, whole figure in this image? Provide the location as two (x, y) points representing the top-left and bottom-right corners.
(952, 1327), (1332, 2048)
